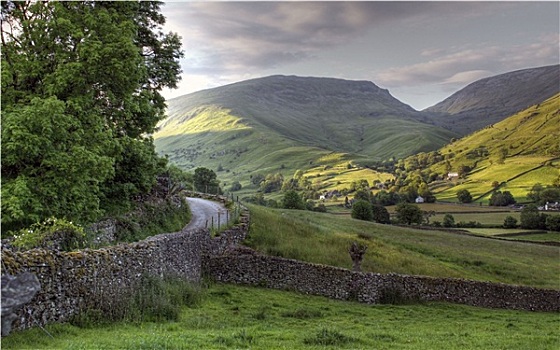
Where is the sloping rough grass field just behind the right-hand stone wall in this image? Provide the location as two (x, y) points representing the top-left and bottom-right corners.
(247, 206), (560, 289)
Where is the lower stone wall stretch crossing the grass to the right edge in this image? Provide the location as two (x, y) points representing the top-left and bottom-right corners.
(203, 249), (560, 311)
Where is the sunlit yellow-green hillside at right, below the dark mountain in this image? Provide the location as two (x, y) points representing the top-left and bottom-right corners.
(405, 94), (560, 202)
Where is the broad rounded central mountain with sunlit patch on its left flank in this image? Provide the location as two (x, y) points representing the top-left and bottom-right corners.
(154, 76), (457, 182)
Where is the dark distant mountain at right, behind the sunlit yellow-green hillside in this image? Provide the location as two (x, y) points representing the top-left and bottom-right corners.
(424, 65), (560, 135)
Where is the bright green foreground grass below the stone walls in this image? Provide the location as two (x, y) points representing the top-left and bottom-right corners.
(2, 285), (560, 350)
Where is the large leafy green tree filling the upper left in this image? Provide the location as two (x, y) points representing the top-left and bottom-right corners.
(1, 1), (182, 228)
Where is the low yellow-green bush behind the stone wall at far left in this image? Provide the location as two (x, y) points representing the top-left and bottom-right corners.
(12, 217), (86, 251)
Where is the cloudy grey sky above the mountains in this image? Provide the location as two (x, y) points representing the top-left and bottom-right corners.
(158, 1), (560, 110)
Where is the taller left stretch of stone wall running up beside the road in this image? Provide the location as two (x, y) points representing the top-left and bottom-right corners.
(2, 197), (249, 330)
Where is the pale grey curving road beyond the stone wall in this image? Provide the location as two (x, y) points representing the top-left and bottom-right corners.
(183, 197), (227, 230)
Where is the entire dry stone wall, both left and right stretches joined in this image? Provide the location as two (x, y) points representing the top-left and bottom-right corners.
(2, 198), (560, 330)
